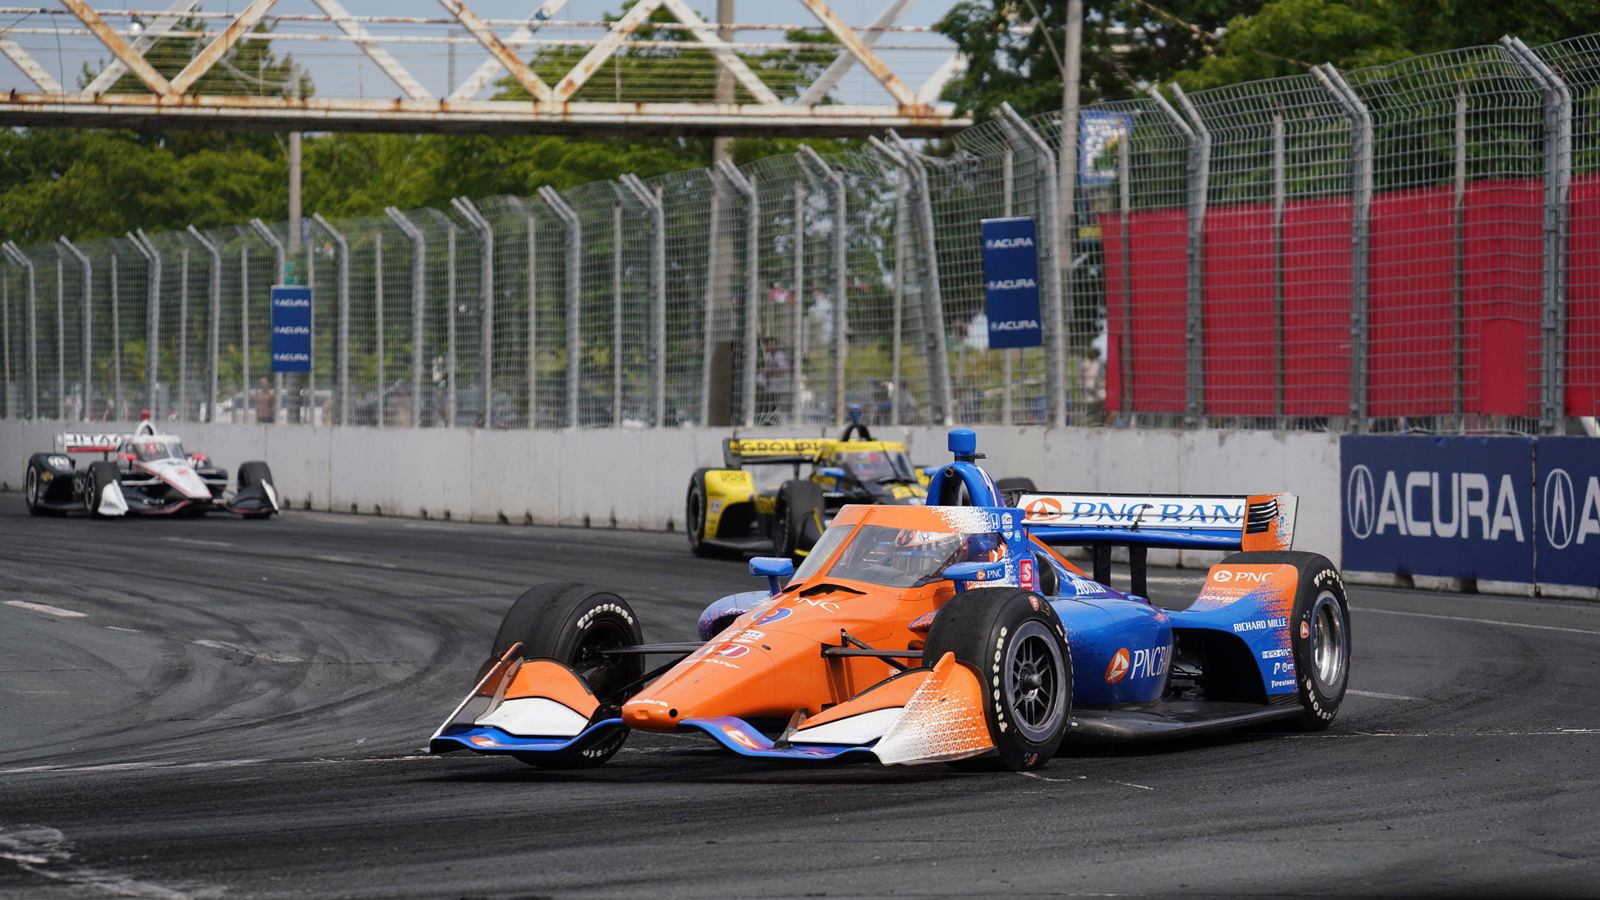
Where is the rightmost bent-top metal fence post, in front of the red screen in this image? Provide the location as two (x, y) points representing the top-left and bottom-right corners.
(1501, 37), (1573, 434)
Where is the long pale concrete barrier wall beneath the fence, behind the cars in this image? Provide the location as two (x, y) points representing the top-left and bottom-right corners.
(0, 421), (1339, 565)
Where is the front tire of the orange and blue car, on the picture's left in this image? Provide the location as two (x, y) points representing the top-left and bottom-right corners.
(480, 583), (645, 769)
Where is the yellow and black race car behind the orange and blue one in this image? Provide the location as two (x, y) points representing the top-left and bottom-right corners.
(683, 405), (1034, 557)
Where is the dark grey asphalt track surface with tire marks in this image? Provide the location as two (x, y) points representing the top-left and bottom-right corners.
(0, 495), (1600, 900)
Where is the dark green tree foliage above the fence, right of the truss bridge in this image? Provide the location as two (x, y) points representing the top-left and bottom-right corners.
(936, 0), (1600, 117)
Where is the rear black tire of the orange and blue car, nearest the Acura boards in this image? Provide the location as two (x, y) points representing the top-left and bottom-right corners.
(1222, 551), (1350, 732)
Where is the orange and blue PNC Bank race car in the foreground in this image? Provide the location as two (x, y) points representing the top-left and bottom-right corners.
(429, 429), (1350, 770)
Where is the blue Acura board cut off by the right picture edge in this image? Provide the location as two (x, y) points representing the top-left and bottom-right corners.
(1534, 437), (1600, 588)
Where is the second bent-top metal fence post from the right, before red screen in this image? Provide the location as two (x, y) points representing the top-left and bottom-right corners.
(1310, 62), (1373, 434)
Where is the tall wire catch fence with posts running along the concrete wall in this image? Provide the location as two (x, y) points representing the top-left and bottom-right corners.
(0, 37), (1600, 432)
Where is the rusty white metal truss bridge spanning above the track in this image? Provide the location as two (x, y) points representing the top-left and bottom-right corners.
(0, 0), (971, 136)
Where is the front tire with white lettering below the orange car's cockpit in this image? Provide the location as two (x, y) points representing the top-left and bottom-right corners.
(922, 588), (1072, 772)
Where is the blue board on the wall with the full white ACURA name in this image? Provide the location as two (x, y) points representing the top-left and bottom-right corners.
(1339, 434), (1538, 585)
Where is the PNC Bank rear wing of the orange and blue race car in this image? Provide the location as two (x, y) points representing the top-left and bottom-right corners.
(1016, 493), (1298, 596)
